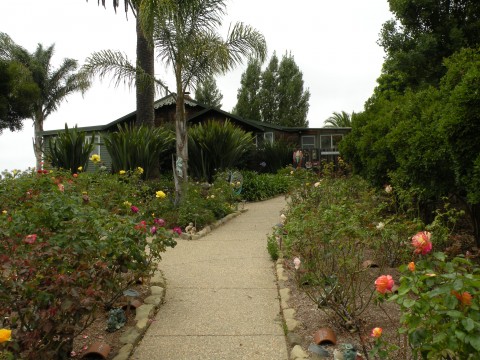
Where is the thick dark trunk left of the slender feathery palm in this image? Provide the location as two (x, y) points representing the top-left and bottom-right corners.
(136, 14), (155, 127)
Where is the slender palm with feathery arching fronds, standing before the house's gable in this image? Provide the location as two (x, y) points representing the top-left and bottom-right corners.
(85, 0), (267, 200)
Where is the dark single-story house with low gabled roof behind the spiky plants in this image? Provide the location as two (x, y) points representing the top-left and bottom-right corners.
(42, 94), (350, 167)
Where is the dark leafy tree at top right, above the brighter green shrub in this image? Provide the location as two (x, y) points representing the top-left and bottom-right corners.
(379, 0), (480, 91)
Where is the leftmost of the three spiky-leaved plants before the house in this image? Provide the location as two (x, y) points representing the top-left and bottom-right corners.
(45, 124), (95, 173)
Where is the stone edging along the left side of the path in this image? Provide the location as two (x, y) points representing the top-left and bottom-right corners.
(112, 209), (248, 360)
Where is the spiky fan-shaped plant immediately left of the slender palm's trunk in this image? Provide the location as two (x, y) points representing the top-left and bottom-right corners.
(105, 125), (174, 178)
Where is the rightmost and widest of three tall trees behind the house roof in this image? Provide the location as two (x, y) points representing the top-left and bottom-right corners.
(278, 54), (310, 127)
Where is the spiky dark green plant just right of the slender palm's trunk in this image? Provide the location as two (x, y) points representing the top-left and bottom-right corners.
(188, 120), (253, 182)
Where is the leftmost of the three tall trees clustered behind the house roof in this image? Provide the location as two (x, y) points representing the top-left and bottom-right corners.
(233, 58), (262, 121)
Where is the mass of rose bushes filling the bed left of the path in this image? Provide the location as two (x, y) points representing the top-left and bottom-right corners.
(0, 171), (175, 359)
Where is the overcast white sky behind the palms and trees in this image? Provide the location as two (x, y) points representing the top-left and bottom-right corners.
(0, 0), (393, 171)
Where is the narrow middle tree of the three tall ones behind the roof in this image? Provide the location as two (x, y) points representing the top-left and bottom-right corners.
(258, 52), (278, 125)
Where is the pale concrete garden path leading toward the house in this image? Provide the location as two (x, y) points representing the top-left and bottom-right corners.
(131, 197), (288, 360)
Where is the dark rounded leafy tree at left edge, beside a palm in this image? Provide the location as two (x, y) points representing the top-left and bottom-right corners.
(0, 60), (40, 134)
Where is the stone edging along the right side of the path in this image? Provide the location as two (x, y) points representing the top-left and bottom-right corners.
(276, 256), (310, 360)
